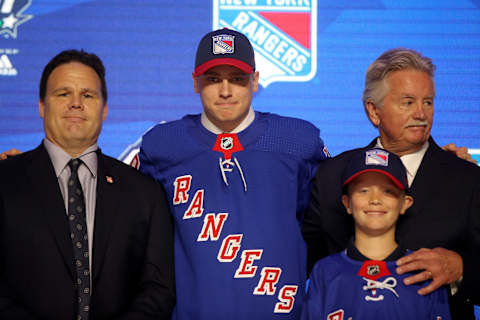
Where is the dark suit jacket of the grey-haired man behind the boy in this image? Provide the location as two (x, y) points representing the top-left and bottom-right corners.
(303, 138), (480, 320)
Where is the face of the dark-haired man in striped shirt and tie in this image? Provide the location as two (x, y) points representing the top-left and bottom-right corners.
(39, 62), (107, 157)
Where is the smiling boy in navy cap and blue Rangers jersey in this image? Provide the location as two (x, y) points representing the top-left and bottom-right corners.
(302, 149), (450, 320)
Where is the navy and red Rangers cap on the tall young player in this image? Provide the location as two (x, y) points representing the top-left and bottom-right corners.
(194, 28), (255, 77)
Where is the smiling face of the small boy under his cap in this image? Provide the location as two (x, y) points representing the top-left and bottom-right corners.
(342, 172), (413, 236)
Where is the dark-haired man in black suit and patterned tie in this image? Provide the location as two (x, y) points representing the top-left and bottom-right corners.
(0, 50), (175, 320)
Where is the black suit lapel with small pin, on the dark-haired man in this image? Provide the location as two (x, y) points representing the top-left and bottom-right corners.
(92, 155), (122, 281)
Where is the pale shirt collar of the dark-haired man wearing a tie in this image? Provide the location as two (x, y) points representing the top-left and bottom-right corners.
(43, 138), (98, 178)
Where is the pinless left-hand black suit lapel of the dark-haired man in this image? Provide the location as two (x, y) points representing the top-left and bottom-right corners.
(26, 144), (75, 279)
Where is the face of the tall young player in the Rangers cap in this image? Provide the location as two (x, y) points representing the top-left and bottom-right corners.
(193, 65), (258, 132)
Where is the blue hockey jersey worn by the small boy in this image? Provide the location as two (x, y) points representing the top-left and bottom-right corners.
(302, 251), (450, 320)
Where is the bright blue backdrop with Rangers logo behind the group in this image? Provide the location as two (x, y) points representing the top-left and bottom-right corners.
(0, 0), (480, 318)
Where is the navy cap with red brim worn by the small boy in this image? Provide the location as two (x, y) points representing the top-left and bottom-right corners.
(342, 148), (409, 194)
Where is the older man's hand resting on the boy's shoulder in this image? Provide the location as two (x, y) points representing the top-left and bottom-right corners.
(397, 248), (463, 295)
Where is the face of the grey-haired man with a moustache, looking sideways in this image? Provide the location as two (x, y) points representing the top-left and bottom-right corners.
(366, 69), (435, 156)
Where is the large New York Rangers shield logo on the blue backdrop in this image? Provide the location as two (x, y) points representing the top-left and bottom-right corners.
(213, 0), (317, 87)
